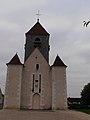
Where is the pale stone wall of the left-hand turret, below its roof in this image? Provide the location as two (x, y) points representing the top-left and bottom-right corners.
(4, 65), (22, 109)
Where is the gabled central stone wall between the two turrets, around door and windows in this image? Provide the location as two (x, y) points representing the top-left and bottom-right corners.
(21, 48), (51, 109)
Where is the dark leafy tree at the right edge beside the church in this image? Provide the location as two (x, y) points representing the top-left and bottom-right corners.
(81, 83), (90, 105)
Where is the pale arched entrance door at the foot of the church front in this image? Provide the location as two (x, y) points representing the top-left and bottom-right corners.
(32, 94), (40, 110)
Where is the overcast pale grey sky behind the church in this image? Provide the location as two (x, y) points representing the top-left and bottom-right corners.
(0, 0), (90, 97)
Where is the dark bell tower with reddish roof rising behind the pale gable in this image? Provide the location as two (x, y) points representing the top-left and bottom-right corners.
(24, 19), (50, 62)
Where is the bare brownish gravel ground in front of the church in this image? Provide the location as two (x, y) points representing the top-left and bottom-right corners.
(0, 110), (90, 120)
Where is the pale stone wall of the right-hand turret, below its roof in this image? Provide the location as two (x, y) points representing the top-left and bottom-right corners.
(52, 66), (67, 110)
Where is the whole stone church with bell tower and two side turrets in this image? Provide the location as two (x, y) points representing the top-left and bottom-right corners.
(4, 20), (67, 110)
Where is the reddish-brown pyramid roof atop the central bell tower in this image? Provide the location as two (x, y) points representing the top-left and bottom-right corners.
(26, 21), (50, 36)
